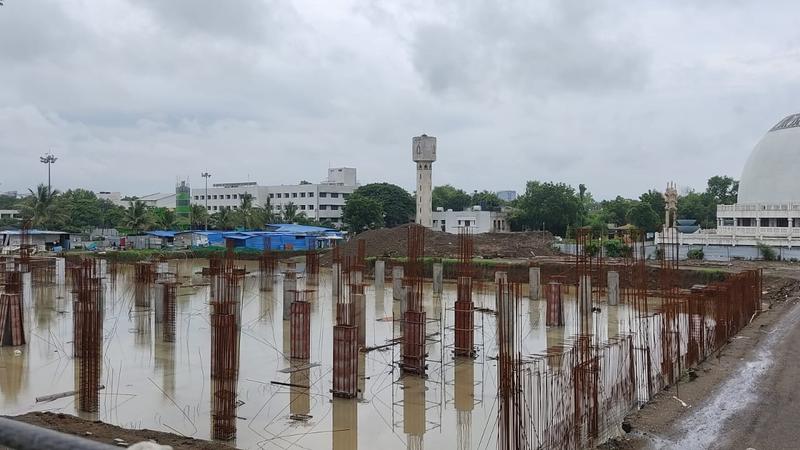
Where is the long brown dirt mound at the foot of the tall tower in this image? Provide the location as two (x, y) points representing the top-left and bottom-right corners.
(323, 225), (558, 263)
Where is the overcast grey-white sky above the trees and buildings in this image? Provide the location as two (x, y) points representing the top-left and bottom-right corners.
(0, 0), (800, 198)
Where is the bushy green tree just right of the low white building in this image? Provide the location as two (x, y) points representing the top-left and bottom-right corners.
(509, 181), (580, 236)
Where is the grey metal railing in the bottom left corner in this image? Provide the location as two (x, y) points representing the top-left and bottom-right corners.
(0, 417), (119, 450)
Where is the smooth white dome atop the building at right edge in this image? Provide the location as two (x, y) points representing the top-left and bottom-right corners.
(738, 114), (800, 203)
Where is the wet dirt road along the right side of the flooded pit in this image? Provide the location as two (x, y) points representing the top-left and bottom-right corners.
(606, 270), (800, 450)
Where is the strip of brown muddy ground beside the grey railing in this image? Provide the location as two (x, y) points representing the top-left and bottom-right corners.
(11, 412), (231, 450)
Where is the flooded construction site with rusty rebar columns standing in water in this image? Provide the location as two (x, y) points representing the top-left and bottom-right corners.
(0, 226), (761, 449)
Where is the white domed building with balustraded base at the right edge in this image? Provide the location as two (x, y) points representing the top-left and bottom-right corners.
(680, 114), (800, 258)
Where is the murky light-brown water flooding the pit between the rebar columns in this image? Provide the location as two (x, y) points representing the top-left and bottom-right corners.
(0, 260), (644, 449)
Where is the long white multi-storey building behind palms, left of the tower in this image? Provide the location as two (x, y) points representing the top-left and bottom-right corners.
(192, 167), (358, 226)
